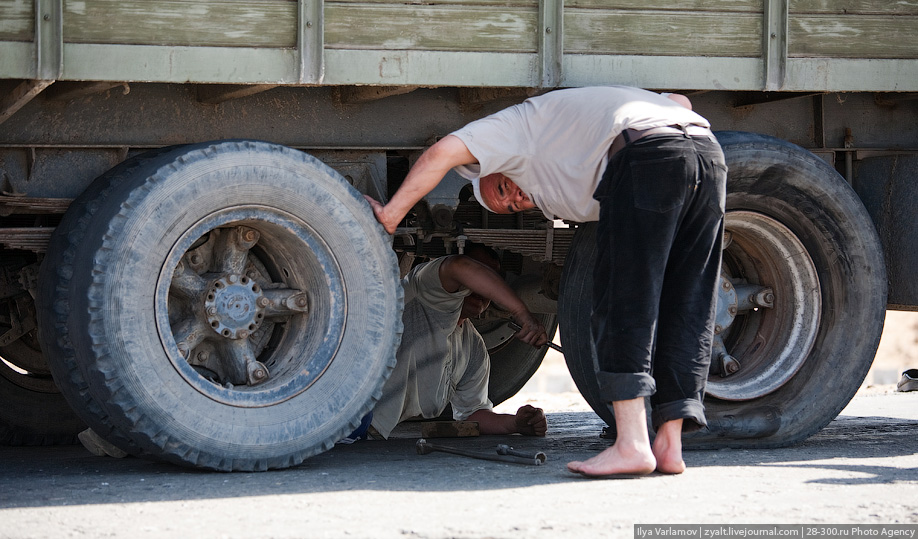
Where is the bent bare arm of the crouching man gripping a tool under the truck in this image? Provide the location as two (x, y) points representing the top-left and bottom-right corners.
(440, 256), (548, 347)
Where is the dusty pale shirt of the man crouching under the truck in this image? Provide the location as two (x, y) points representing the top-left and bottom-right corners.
(371, 257), (494, 438)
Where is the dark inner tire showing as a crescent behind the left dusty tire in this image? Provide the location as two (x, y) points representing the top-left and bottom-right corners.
(37, 147), (181, 455)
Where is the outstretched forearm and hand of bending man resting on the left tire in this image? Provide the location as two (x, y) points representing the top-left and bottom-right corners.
(365, 135), (478, 234)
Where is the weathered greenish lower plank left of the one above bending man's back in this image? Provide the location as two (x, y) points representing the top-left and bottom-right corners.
(325, 3), (539, 52)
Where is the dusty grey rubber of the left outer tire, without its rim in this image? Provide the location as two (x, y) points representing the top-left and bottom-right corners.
(73, 141), (401, 469)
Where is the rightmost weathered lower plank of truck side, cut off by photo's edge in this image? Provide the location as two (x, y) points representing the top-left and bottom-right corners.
(787, 15), (918, 58)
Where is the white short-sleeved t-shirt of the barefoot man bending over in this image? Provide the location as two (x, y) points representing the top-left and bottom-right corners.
(452, 86), (710, 222)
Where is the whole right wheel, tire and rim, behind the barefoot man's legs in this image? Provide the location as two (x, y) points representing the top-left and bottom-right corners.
(559, 132), (886, 448)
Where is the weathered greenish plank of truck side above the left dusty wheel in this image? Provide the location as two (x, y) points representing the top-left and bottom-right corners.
(64, 0), (297, 47)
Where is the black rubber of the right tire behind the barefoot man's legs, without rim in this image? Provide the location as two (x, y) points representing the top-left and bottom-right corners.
(559, 132), (886, 448)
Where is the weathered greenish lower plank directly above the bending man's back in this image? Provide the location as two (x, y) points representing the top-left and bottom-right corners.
(564, 10), (763, 57)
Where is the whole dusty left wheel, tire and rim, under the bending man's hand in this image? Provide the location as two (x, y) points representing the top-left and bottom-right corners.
(51, 141), (402, 471)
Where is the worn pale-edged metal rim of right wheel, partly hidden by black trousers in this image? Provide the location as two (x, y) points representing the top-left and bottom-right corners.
(706, 211), (822, 401)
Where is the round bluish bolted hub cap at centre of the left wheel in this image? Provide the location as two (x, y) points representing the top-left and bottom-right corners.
(204, 274), (269, 339)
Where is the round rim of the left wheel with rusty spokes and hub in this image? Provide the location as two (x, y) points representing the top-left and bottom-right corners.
(156, 206), (347, 407)
